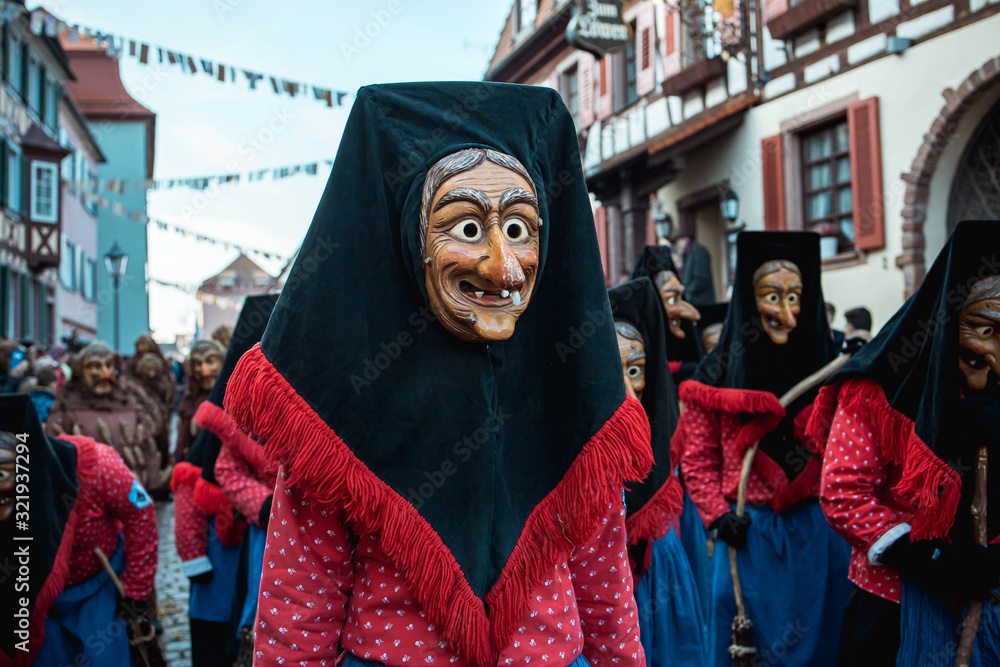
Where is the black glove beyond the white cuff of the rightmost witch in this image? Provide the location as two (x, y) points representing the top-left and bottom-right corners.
(879, 535), (1000, 601)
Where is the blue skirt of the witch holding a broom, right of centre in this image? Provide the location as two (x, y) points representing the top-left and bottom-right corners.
(706, 502), (851, 667)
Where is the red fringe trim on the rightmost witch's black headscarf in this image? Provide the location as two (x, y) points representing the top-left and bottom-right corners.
(807, 379), (962, 540)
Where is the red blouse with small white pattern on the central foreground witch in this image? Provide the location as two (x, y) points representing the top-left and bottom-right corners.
(250, 470), (646, 667)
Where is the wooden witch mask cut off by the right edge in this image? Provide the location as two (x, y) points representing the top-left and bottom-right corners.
(958, 276), (1000, 391)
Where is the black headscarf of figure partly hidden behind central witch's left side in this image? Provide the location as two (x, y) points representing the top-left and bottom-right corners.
(184, 294), (278, 486)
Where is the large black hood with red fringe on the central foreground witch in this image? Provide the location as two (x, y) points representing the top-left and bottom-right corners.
(226, 83), (646, 662)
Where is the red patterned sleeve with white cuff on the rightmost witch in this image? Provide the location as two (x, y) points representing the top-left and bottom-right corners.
(820, 380), (914, 603)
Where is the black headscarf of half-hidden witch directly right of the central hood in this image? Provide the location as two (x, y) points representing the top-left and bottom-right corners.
(608, 277), (680, 516)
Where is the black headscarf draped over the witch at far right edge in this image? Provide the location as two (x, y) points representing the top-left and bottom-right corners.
(830, 220), (1000, 537)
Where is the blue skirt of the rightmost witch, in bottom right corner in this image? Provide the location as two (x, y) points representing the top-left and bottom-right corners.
(896, 580), (1000, 667)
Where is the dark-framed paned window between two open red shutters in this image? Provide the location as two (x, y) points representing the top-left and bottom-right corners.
(801, 118), (854, 252)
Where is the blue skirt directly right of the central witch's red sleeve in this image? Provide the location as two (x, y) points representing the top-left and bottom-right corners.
(635, 528), (705, 667)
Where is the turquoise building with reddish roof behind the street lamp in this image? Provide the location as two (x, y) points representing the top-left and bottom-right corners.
(59, 33), (156, 348)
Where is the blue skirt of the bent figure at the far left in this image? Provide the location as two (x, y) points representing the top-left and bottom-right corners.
(32, 535), (135, 667)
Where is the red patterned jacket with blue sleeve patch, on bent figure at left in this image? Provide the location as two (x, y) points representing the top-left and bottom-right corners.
(61, 435), (159, 600)
